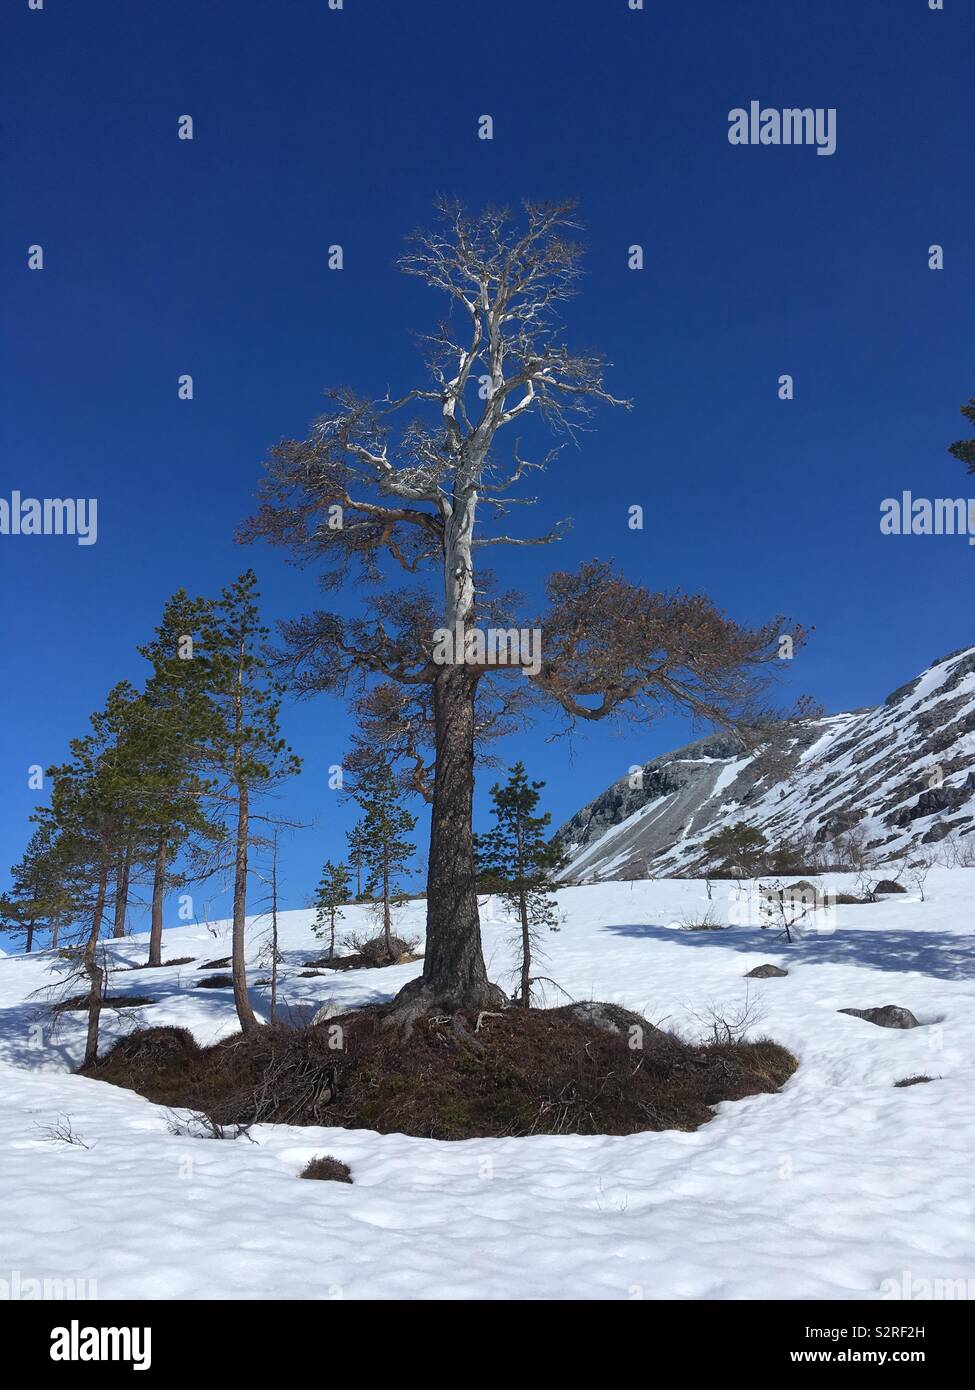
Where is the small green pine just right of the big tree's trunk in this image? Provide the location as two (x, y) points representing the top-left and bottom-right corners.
(474, 762), (565, 1009)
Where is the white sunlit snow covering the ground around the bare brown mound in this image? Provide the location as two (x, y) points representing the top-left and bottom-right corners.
(0, 869), (975, 1300)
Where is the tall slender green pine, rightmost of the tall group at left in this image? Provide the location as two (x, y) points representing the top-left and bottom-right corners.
(209, 570), (300, 1033)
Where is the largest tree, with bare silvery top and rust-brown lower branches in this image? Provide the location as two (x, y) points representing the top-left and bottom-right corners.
(242, 200), (800, 1027)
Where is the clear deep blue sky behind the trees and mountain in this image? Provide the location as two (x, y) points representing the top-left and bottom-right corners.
(0, 0), (975, 934)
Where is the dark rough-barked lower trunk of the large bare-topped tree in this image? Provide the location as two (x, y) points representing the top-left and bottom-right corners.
(391, 666), (505, 1026)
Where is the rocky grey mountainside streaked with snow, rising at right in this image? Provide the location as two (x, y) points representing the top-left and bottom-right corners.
(559, 646), (975, 881)
